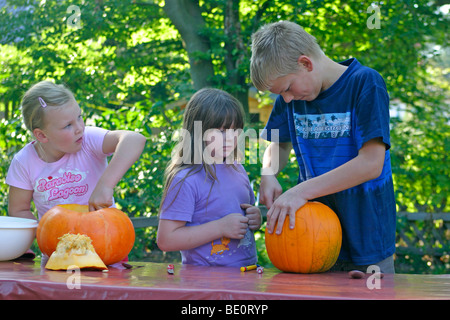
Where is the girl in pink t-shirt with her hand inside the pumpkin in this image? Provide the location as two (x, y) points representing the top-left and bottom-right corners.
(6, 81), (145, 219)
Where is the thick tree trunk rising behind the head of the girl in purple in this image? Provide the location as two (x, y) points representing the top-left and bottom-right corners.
(164, 0), (214, 90)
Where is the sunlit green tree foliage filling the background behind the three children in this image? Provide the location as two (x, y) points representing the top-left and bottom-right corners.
(0, 0), (450, 272)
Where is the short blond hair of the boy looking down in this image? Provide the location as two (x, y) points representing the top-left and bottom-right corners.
(250, 21), (323, 91)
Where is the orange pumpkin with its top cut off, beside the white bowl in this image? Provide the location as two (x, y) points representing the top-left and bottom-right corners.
(36, 204), (135, 265)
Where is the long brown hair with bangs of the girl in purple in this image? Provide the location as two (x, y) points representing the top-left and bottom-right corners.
(160, 88), (245, 214)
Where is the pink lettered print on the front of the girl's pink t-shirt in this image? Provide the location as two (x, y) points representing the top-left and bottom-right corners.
(35, 169), (88, 202)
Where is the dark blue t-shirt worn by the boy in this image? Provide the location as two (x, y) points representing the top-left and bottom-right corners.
(262, 58), (396, 265)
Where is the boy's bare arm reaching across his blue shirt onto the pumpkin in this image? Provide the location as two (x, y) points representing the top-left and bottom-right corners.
(267, 139), (386, 233)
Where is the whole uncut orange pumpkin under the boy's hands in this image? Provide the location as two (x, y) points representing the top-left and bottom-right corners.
(265, 202), (342, 273)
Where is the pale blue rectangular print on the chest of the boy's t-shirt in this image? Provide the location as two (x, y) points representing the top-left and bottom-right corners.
(294, 112), (351, 139)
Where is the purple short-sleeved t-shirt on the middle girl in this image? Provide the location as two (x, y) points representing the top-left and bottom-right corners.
(160, 164), (257, 267)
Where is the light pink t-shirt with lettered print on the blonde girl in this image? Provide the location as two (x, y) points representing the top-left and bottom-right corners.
(6, 127), (114, 219)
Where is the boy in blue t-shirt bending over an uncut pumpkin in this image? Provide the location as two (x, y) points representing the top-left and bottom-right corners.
(250, 21), (396, 273)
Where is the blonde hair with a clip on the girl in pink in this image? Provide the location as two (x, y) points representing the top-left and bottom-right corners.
(22, 81), (75, 133)
